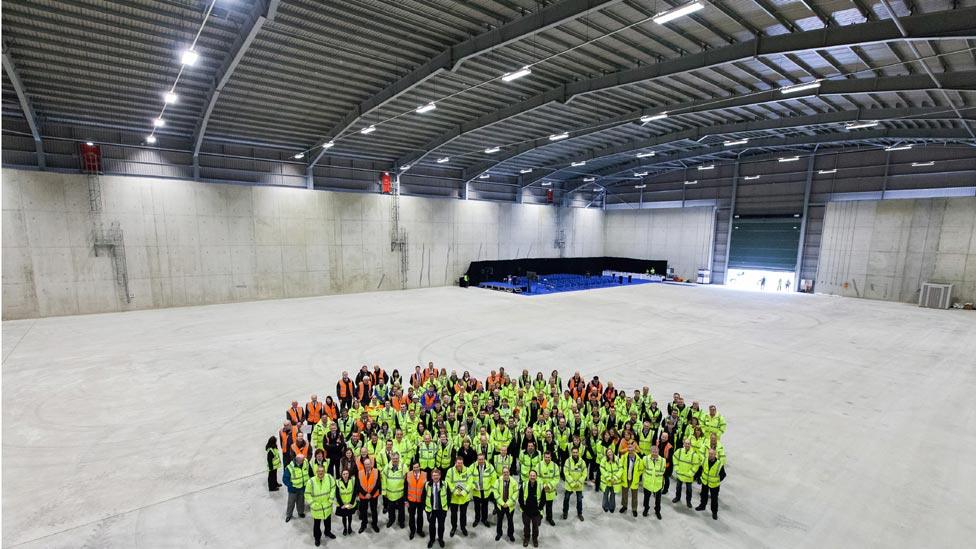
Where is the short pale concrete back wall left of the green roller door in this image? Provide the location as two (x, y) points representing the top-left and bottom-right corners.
(603, 207), (715, 280)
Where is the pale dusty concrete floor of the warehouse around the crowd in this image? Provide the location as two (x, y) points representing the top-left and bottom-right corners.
(2, 285), (976, 548)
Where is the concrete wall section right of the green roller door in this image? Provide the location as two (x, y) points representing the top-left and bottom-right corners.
(816, 198), (976, 302)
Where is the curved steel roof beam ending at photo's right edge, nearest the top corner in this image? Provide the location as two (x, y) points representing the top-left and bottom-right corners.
(396, 8), (976, 166)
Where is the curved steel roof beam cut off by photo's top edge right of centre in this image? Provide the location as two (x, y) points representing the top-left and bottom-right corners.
(309, 0), (622, 167)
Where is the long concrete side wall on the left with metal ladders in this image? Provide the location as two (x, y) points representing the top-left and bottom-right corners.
(2, 169), (603, 319)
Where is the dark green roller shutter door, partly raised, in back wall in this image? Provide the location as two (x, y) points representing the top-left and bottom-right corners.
(729, 217), (800, 272)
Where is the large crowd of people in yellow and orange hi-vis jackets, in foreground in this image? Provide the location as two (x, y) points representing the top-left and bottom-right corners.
(266, 363), (726, 548)
